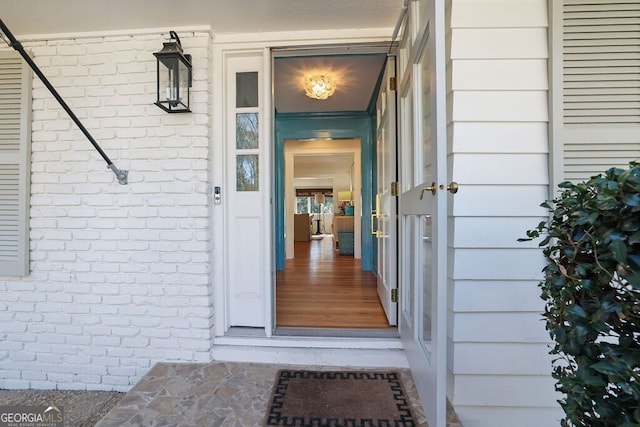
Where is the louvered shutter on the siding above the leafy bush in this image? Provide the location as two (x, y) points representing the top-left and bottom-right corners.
(560, 0), (640, 181)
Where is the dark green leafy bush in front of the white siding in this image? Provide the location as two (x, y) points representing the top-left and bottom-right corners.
(521, 162), (640, 427)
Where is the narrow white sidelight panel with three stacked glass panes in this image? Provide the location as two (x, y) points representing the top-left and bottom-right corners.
(223, 55), (270, 328)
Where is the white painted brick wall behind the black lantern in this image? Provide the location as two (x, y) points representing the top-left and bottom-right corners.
(0, 28), (213, 391)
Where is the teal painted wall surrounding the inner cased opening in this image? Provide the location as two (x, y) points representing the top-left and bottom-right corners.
(273, 113), (376, 271)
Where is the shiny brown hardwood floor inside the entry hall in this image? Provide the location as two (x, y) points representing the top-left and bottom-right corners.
(276, 235), (389, 328)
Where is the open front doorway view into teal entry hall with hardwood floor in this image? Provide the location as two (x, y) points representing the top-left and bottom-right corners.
(273, 46), (397, 332)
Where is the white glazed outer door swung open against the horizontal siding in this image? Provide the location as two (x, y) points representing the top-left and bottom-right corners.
(399, 1), (455, 427)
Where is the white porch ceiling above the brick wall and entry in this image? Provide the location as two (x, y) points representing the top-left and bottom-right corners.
(0, 0), (403, 36)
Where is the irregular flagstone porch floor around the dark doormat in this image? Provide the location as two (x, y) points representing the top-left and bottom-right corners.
(96, 362), (459, 427)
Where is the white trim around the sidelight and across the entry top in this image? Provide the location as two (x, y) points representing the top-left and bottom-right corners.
(210, 30), (389, 340)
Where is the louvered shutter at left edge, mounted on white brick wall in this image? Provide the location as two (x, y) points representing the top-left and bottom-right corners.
(0, 52), (31, 276)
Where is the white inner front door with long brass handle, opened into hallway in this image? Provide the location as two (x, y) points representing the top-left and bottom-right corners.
(371, 57), (398, 325)
